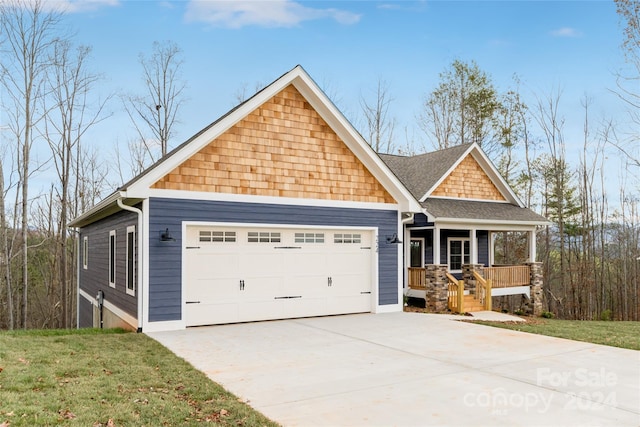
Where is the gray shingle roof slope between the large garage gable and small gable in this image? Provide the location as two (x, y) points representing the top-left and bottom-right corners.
(380, 144), (471, 200)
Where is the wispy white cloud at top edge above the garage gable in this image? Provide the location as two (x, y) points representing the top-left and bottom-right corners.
(185, 0), (360, 28)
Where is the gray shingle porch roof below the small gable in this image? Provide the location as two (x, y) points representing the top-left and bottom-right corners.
(421, 198), (547, 223)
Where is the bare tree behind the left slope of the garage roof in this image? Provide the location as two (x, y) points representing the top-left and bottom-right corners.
(123, 41), (185, 167)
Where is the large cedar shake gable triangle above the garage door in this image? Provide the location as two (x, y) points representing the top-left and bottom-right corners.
(152, 85), (395, 203)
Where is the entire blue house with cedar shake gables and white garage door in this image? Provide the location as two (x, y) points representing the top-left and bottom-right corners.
(70, 66), (544, 332)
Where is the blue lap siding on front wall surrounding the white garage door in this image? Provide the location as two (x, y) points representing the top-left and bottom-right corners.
(148, 198), (399, 322)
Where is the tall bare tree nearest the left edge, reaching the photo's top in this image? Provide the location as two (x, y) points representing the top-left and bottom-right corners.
(0, 0), (61, 328)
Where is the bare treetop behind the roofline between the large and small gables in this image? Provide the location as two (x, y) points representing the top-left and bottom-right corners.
(360, 79), (396, 153)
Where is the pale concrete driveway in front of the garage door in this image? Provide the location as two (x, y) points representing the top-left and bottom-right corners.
(150, 313), (640, 426)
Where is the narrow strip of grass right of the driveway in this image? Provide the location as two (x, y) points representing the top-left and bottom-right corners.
(473, 318), (640, 350)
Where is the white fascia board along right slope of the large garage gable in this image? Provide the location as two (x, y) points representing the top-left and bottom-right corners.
(292, 75), (422, 212)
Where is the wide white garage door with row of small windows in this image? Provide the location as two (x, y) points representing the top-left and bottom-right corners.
(184, 226), (375, 326)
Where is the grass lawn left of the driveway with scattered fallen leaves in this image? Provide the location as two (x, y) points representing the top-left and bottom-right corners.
(0, 329), (276, 427)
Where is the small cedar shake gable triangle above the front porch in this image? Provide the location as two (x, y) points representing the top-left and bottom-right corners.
(430, 154), (506, 201)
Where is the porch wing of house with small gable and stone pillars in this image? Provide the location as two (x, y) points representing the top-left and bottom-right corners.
(380, 144), (549, 314)
